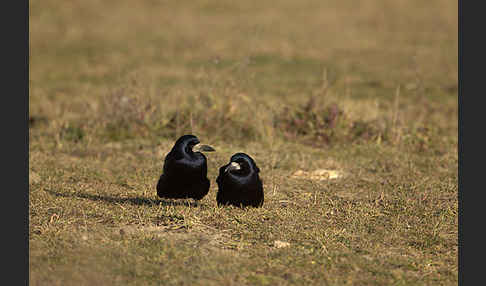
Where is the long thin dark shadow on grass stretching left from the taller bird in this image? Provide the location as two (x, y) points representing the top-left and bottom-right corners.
(45, 189), (200, 207)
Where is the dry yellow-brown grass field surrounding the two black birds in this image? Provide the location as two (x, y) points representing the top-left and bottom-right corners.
(29, 0), (458, 285)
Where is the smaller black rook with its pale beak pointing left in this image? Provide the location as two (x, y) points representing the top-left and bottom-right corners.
(216, 153), (263, 207)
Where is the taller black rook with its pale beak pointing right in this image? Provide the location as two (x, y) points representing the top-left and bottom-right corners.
(157, 135), (215, 201)
